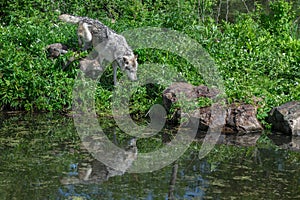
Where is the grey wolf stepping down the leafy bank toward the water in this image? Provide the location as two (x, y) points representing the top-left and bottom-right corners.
(59, 14), (138, 85)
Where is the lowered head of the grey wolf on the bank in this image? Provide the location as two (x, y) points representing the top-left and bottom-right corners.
(122, 54), (138, 81)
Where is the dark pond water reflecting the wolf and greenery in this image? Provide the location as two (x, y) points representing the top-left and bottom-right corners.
(0, 114), (300, 200)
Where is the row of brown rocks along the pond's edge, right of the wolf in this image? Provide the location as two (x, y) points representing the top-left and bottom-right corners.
(163, 82), (300, 136)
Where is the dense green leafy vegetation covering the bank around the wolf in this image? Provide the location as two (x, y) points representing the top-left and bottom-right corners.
(0, 0), (300, 128)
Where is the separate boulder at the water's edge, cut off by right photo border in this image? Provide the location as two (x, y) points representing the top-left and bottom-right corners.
(267, 101), (300, 136)
